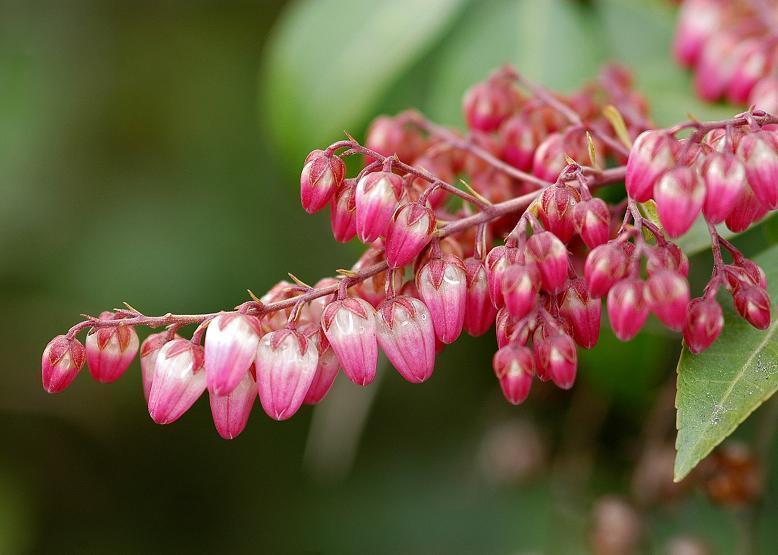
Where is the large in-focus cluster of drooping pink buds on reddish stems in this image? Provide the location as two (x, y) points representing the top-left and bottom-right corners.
(42, 63), (778, 438)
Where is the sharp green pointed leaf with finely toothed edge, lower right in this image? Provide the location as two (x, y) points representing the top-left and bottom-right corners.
(675, 246), (778, 480)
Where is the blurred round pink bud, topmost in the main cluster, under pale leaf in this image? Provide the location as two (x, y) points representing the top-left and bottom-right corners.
(462, 77), (521, 132)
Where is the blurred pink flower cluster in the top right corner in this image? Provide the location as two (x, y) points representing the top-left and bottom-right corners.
(674, 0), (778, 113)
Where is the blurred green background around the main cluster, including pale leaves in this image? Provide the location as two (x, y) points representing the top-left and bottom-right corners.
(0, 0), (778, 553)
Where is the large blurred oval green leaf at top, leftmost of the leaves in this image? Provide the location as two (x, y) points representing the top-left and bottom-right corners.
(261, 0), (465, 167)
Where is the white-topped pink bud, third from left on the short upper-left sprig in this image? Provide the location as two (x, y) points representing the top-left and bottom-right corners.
(355, 171), (403, 243)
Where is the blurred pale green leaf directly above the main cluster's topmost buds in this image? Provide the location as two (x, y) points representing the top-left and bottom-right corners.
(423, 0), (606, 124)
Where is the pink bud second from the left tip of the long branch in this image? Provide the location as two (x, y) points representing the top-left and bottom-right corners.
(86, 318), (139, 383)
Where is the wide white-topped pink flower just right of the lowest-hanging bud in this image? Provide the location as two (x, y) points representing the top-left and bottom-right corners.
(255, 328), (319, 420)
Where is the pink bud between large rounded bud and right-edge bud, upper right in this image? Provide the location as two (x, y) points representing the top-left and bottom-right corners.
(702, 152), (746, 224)
